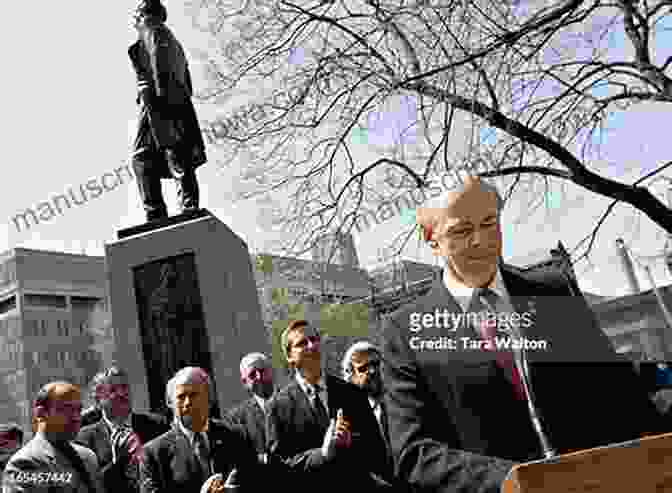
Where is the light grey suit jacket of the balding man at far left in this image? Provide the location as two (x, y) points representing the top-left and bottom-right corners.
(2, 433), (105, 493)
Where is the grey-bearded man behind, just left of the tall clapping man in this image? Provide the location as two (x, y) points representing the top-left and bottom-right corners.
(227, 353), (275, 461)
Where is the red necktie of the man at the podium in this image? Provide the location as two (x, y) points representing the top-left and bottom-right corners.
(469, 288), (526, 400)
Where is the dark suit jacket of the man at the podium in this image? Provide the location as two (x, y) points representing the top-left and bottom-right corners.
(383, 265), (666, 493)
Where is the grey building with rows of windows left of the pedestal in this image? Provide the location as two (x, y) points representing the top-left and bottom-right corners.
(0, 248), (111, 434)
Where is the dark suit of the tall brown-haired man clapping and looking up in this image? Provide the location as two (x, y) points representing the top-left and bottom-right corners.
(267, 375), (396, 491)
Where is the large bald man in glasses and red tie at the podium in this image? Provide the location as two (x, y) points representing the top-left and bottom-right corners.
(383, 177), (666, 493)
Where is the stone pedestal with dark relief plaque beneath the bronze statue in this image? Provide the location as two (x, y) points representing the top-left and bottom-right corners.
(105, 211), (270, 412)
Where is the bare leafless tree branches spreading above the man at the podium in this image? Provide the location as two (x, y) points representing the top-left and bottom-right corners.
(188, 0), (672, 270)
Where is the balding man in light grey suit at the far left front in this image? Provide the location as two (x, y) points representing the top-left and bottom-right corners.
(2, 382), (104, 493)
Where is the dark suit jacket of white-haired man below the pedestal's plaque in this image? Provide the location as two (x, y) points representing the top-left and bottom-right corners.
(140, 419), (284, 493)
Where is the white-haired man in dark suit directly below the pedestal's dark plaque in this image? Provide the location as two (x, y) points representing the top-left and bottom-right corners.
(140, 367), (278, 493)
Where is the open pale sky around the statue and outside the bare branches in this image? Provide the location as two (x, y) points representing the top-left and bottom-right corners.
(0, 0), (672, 296)
